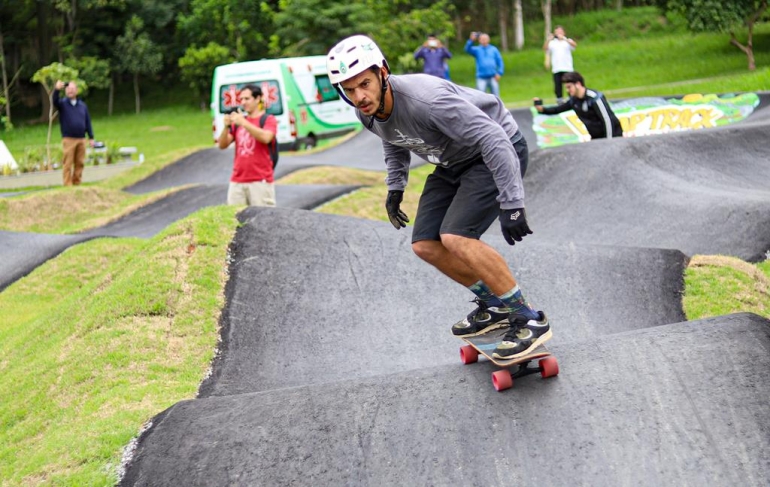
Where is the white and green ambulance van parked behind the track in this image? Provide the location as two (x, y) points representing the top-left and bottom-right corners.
(211, 56), (361, 150)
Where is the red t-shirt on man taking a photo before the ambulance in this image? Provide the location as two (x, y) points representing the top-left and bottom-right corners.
(230, 115), (278, 183)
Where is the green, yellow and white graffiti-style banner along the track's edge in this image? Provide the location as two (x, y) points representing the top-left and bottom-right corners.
(531, 93), (759, 148)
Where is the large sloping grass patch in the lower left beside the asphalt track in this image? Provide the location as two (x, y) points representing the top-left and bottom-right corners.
(0, 206), (237, 486)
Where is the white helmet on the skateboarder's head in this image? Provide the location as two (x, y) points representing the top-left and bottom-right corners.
(326, 35), (390, 86)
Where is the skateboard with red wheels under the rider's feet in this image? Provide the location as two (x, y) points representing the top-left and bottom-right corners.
(460, 328), (559, 392)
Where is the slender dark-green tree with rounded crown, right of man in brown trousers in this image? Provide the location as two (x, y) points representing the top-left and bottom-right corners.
(115, 15), (163, 113)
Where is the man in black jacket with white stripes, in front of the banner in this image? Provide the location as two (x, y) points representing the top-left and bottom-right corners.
(534, 72), (623, 139)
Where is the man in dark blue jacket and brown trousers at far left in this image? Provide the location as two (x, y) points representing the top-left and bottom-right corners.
(52, 80), (94, 186)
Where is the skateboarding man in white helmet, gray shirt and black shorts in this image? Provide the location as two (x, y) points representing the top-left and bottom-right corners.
(326, 35), (551, 359)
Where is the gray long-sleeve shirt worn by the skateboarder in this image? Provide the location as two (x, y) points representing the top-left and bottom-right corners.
(358, 74), (524, 209)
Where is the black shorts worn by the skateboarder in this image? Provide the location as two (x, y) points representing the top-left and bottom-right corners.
(412, 131), (529, 243)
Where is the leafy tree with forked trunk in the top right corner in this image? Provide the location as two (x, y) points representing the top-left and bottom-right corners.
(659, 0), (768, 71)
